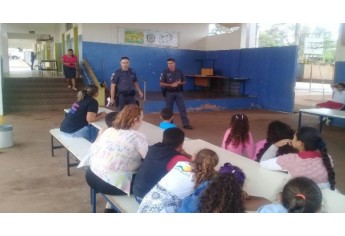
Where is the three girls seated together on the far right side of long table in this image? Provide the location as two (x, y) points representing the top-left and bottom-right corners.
(222, 114), (335, 190)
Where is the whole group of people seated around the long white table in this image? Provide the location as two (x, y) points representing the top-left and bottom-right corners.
(61, 86), (335, 213)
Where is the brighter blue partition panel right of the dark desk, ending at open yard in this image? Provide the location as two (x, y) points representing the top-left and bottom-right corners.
(240, 46), (298, 112)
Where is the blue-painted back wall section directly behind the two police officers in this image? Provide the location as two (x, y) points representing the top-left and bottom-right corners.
(83, 42), (205, 91)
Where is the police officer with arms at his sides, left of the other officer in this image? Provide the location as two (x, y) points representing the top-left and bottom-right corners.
(110, 57), (143, 111)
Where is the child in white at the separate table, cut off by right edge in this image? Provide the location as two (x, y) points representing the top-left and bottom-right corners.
(316, 83), (345, 110)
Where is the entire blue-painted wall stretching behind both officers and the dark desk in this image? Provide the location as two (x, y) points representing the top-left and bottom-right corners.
(82, 42), (297, 112)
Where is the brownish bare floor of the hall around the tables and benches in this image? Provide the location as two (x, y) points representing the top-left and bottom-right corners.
(0, 102), (345, 213)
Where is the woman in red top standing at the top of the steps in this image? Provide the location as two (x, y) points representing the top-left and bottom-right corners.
(62, 49), (79, 91)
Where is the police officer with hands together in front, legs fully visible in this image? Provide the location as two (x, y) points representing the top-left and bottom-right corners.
(159, 58), (193, 129)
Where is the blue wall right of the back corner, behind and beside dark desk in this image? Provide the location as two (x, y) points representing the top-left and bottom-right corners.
(206, 46), (298, 112)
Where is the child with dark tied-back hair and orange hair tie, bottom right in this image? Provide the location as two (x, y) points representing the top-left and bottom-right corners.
(257, 177), (322, 213)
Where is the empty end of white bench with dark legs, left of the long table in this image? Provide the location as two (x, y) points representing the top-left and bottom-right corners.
(50, 128), (91, 176)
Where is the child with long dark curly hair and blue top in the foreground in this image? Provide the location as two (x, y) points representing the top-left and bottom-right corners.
(178, 162), (270, 213)
